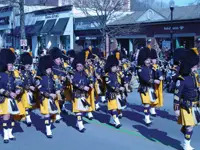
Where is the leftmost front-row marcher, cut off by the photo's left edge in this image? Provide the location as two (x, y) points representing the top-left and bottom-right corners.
(0, 49), (21, 143)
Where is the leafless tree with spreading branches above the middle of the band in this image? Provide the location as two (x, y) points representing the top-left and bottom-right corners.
(74, 0), (130, 51)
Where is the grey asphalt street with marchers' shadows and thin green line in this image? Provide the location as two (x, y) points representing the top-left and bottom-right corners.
(0, 91), (200, 150)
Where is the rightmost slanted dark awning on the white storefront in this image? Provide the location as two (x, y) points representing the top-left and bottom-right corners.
(51, 18), (69, 35)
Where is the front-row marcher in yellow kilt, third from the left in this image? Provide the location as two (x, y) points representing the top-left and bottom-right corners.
(72, 52), (93, 132)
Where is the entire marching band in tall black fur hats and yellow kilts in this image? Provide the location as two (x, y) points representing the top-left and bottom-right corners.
(0, 38), (200, 150)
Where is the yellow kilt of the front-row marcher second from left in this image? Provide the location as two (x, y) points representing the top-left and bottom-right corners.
(40, 98), (60, 115)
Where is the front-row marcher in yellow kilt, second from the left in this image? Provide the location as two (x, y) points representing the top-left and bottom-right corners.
(37, 55), (60, 138)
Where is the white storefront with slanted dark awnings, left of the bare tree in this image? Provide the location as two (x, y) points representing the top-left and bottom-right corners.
(15, 5), (74, 56)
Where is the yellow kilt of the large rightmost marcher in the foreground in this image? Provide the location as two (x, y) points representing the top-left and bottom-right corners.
(178, 108), (195, 126)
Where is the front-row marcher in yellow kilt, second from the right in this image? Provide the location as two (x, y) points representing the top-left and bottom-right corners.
(138, 48), (160, 126)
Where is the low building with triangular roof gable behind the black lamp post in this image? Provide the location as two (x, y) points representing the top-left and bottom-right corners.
(110, 5), (200, 51)
